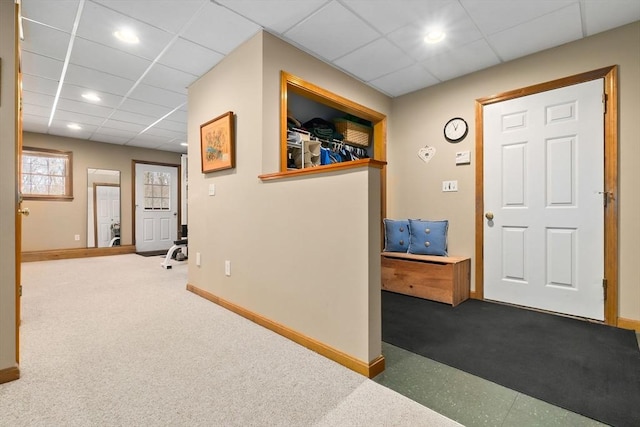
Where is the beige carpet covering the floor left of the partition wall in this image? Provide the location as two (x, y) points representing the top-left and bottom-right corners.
(0, 254), (458, 427)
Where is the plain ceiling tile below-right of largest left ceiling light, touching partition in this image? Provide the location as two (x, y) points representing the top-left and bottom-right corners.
(158, 38), (224, 76)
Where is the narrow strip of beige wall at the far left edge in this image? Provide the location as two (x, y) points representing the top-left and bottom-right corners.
(0, 1), (17, 371)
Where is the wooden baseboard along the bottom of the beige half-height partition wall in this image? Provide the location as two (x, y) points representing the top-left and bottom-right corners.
(187, 284), (385, 378)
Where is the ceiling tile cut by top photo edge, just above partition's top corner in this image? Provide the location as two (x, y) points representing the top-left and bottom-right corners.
(217, 0), (327, 32)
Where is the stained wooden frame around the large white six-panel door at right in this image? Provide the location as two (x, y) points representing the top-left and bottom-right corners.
(473, 65), (618, 326)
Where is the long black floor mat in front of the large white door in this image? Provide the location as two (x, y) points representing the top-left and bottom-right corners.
(382, 291), (640, 427)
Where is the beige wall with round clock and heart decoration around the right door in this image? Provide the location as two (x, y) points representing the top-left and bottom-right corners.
(387, 22), (640, 320)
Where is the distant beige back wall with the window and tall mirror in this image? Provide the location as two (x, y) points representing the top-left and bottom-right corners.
(22, 132), (180, 251)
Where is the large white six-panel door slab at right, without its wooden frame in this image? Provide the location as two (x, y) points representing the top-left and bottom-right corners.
(483, 79), (604, 320)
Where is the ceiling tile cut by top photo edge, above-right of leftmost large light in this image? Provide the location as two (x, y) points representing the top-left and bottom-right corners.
(94, 0), (210, 34)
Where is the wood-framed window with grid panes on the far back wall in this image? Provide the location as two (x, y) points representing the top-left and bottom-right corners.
(21, 147), (73, 200)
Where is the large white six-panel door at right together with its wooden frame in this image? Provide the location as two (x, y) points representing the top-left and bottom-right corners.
(475, 67), (617, 324)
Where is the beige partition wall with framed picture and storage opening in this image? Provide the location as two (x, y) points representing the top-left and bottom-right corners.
(189, 33), (390, 362)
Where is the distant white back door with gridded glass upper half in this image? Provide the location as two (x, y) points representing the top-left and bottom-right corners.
(135, 163), (178, 252)
